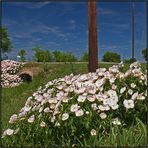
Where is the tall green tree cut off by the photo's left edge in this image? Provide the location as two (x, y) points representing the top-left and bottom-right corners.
(0, 27), (13, 53)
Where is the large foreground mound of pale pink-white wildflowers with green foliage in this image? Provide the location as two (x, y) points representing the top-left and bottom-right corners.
(2, 62), (147, 147)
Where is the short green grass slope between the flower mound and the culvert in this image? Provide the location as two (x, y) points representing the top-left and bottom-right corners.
(2, 63), (87, 127)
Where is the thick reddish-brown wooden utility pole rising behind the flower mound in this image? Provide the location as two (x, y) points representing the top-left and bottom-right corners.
(88, 0), (98, 72)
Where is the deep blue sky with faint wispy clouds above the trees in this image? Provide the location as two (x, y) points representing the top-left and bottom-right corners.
(2, 1), (146, 61)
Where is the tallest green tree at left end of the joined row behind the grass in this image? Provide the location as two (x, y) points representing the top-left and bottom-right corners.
(32, 46), (53, 62)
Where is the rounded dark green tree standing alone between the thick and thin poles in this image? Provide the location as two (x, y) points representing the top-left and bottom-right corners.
(102, 51), (121, 63)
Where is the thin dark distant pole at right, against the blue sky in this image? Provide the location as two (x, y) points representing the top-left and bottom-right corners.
(132, 2), (134, 62)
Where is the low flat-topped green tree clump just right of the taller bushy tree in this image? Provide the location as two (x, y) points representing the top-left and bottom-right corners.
(53, 51), (77, 62)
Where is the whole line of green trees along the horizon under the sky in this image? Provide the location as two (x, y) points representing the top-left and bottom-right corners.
(0, 27), (148, 63)
